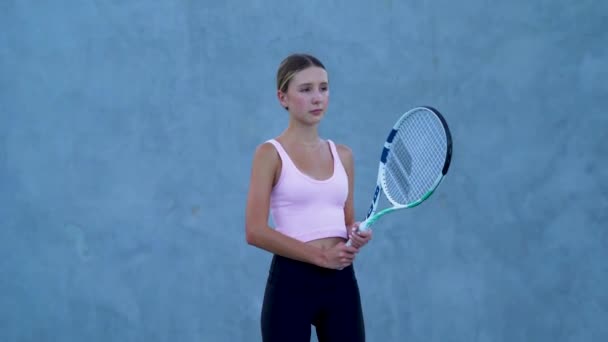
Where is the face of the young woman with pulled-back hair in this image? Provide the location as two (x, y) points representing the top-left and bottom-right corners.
(279, 66), (329, 124)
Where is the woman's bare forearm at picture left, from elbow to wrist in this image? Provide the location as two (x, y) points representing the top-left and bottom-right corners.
(247, 227), (327, 267)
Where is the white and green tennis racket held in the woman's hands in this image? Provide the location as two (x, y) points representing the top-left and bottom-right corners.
(347, 106), (452, 246)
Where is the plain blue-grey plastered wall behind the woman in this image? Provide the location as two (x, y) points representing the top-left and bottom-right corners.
(0, 0), (608, 342)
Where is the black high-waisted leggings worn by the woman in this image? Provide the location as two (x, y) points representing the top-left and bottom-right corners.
(261, 255), (365, 342)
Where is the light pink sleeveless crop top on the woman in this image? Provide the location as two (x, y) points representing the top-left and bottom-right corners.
(267, 139), (348, 242)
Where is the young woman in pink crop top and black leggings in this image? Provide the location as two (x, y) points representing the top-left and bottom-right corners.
(246, 54), (371, 342)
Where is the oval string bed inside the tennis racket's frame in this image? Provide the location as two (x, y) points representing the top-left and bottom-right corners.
(383, 111), (447, 205)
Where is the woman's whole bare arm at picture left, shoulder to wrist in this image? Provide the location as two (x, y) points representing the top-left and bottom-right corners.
(245, 144), (328, 267)
